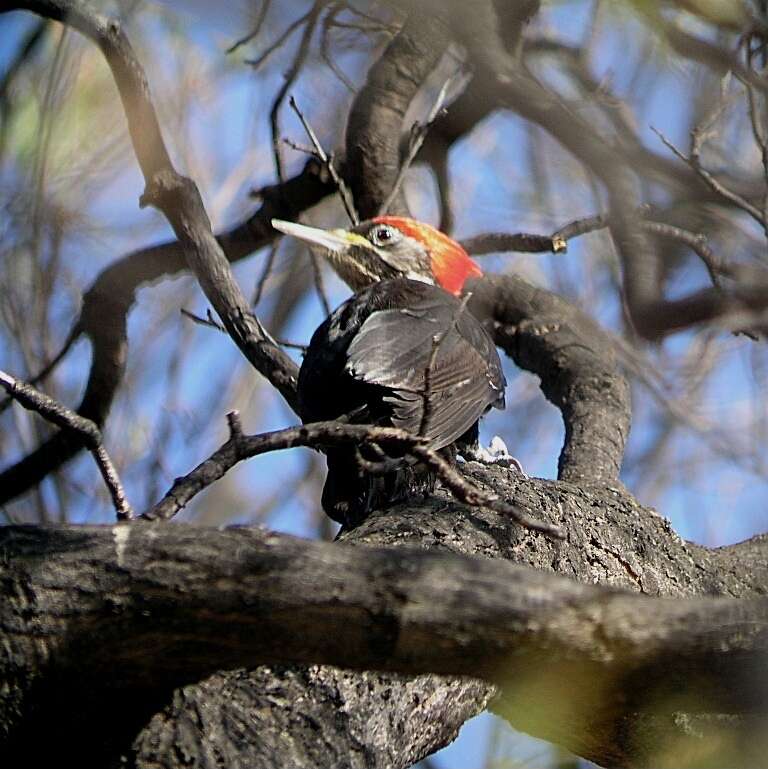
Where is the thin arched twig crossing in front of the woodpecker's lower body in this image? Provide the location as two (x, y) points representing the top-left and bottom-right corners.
(141, 416), (564, 539)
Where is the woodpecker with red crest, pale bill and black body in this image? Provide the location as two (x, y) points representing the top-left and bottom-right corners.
(272, 216), (506, 526)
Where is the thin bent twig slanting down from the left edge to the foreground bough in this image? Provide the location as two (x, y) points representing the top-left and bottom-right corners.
(0, 371), (133, 521)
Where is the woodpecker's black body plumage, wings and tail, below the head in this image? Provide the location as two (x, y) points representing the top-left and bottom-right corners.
(298, 278), (505, 525)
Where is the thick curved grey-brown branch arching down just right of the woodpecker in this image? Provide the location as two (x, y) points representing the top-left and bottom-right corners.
(470, 275), (632, 483)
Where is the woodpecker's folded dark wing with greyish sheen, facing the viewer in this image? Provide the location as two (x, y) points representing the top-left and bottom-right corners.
(346, 291), (505, 448)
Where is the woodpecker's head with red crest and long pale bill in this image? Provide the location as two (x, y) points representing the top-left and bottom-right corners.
(272, 216), (483, 294)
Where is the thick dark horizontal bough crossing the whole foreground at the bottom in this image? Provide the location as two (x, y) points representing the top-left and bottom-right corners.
(0, 524), (768, 765)
